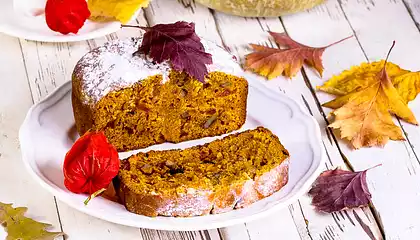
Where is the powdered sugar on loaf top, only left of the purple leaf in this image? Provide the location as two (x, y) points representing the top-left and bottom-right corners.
(74, 38), (170, 103)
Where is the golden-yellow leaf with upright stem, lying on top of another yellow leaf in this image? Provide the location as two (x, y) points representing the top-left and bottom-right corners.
(323, 42), (417, 149)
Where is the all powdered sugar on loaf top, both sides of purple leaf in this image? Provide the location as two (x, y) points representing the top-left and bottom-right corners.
(74, 38), (242, 104)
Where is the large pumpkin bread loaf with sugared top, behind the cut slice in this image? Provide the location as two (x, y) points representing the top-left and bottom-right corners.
(72, 38), (248, 151)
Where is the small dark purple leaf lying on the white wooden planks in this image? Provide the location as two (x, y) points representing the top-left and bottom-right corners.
(309, 168), (378, 213)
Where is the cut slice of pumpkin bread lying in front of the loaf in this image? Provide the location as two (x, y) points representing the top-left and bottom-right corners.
(114, 127), (289, 217)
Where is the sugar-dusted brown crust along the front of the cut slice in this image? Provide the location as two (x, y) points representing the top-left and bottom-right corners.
(114, 128), (290, 217)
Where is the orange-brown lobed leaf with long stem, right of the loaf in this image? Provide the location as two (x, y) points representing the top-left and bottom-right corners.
(245, 32), (352, 79)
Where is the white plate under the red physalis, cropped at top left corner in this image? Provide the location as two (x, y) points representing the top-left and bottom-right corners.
(0, 0), (121, 42)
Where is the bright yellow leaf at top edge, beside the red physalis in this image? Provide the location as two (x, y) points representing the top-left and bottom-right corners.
(88, 0), (150, 23)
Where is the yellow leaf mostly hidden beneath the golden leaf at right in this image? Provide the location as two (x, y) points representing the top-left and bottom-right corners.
(317, 60), (420, 103)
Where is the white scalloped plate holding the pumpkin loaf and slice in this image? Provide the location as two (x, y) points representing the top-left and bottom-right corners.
(19, 77), (325, 230)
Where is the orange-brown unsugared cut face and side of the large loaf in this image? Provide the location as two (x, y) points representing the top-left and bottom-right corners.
(73, 71), (248, 151)
